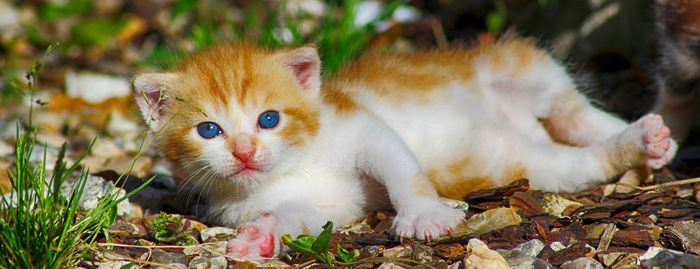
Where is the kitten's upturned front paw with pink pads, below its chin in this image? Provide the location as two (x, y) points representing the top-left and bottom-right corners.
(226, 212), (277, 258)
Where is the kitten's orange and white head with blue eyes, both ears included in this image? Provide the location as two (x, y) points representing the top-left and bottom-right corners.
(133, 44), (321, 191)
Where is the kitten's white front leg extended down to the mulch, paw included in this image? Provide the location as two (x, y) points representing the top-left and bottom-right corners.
(358, 120), (464, 240)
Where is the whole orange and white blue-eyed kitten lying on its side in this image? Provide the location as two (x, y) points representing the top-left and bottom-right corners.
(134, 39), (676, 257)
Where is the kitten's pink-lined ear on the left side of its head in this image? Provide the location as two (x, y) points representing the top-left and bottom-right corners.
(133, 73), (177, 130)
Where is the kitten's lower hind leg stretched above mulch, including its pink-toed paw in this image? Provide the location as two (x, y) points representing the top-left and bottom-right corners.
(520, 114), (675, 191)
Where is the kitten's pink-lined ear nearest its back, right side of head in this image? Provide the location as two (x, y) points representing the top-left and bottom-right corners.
(277, 46), (321, 96)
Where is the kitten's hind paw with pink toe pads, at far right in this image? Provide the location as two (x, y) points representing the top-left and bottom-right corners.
(639, 114), (678, 169)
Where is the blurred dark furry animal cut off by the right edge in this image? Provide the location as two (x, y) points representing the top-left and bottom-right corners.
(654, 0), (700, 140)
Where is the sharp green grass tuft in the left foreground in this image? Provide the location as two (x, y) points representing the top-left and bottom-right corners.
(0, 49), (148, 268)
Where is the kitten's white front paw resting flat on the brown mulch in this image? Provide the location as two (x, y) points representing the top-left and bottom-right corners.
(393, 199), (464, 240)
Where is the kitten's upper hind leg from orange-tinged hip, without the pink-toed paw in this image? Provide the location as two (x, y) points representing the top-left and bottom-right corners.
(477, 41), (627, 147)
